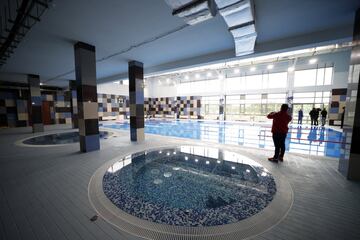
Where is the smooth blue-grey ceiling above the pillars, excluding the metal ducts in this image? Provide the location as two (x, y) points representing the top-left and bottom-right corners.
(0, 0), (360, 85)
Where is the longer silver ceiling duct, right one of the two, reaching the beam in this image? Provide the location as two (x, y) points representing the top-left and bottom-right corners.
(215, 0), (257, 56)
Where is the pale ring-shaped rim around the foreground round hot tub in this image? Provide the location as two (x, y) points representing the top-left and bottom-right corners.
(88, 144), (294, 240)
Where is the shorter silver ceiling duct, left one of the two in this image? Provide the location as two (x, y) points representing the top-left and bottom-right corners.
(165, 0), (216, 25)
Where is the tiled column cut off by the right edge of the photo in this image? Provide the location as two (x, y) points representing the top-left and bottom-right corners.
(339, 9), (360, 180)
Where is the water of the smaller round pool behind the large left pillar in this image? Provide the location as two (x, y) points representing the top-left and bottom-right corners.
(22, 131), (112, 145)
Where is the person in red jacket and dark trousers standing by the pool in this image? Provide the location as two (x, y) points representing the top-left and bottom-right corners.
(267, 104), (291, 162)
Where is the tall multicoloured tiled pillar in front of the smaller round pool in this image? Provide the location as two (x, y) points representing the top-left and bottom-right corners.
(74, 42), (100, 152)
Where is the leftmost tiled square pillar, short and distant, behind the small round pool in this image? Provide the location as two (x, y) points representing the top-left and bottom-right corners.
(27, 74), (44, 133)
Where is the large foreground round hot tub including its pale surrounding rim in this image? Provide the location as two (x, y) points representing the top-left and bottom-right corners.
(89, 146), (292, 239)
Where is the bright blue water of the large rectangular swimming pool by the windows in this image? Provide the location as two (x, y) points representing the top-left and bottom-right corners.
(102, 120), (342, 157)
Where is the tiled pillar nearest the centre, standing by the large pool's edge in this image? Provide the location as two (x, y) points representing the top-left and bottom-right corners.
(129, 61), (145, 141)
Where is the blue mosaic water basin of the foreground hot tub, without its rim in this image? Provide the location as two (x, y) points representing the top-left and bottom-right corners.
(103, 146), (276, 227)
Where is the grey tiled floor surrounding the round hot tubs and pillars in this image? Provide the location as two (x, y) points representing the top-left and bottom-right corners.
(0, 125), (360, 240)
